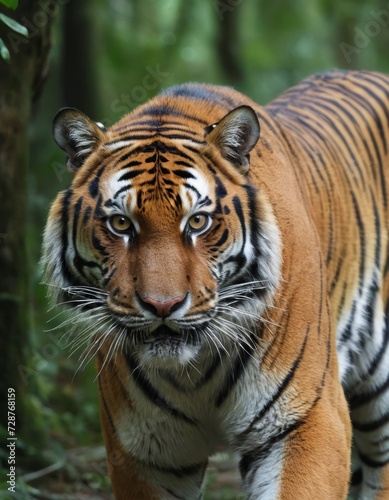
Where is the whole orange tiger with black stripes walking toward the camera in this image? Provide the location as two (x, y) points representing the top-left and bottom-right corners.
(42, 70), (389, 500)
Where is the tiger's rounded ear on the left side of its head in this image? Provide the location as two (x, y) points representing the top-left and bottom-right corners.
(53, 108), (107, 171)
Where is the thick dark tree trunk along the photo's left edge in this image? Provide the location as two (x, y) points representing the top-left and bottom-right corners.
(0, 0), (58, 433)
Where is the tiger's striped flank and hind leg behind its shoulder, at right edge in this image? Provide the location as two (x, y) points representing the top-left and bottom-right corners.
(267, 72), (389, 498)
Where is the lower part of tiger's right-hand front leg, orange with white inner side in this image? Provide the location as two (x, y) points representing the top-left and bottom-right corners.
(240, 390), (350, 500)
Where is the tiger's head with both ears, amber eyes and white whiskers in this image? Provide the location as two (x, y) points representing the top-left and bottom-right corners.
(43, 92), (280, 366)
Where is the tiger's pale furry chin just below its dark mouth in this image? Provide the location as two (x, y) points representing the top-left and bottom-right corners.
(133, 325), (201, 367)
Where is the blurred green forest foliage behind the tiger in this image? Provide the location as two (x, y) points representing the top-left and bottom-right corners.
(6, 0), (389, 498)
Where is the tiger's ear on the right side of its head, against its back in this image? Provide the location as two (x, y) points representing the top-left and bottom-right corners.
(204, 106), (260, 174)
